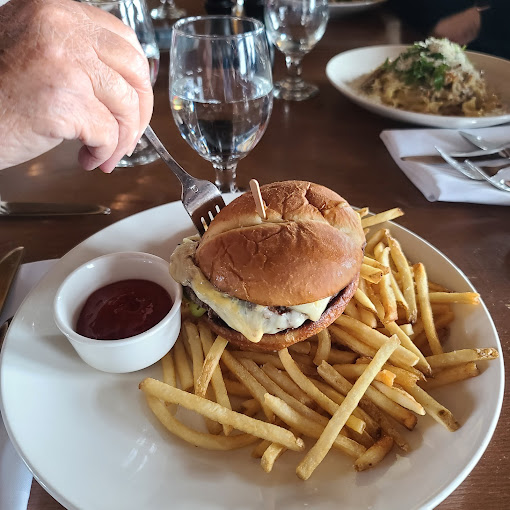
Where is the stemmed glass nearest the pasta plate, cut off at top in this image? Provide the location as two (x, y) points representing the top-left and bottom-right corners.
(264, 0), (329, 101)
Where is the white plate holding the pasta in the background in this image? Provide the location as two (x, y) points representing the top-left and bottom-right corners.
(326, 45), (510, 129)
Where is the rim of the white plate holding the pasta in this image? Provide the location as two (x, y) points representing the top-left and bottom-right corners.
(326, 44), (510, 129)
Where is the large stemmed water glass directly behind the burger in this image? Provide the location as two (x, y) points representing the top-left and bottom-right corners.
(169, 16), (273, 192)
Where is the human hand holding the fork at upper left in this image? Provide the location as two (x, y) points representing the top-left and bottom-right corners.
(0, 0), (154, 173)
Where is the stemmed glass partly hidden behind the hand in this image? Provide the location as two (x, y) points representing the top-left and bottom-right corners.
(80, 0), (159, 167)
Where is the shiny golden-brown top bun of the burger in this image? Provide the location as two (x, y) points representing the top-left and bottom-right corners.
(196, 181), (365, 306)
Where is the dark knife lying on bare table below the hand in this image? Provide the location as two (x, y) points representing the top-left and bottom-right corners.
(0, 201), (111, 217)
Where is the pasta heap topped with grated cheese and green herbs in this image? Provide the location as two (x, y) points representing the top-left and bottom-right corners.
(360, 37), (504, 117)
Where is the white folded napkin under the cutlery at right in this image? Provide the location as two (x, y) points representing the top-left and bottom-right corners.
(381, 125), (510, 205)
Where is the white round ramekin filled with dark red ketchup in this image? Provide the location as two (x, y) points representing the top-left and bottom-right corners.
(54, 252), (182, 373)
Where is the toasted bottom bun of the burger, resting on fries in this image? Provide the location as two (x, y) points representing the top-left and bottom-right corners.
(204, 273), (359, 352)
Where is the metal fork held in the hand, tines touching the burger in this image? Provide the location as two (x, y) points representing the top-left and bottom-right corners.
(145, 126), (225, 235)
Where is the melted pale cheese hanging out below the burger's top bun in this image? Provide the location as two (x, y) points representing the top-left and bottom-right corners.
(170, 237), (331, 343)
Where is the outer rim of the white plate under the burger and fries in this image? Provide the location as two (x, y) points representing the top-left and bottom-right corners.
(0, 197), (505, 510)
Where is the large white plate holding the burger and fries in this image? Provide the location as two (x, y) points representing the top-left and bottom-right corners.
(0, 199), (504, 510)
